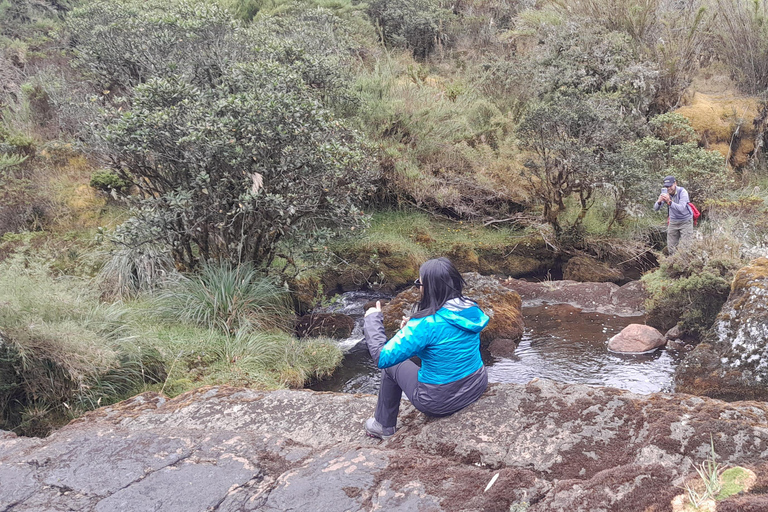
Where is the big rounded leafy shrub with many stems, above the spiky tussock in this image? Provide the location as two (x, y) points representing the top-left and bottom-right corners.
(104, 63), (371, 268)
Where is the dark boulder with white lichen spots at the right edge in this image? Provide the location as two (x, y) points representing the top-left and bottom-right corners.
(675, 258), (768, 400)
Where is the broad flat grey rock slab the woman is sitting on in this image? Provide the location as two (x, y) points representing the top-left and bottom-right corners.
(0, 380), (768, 512)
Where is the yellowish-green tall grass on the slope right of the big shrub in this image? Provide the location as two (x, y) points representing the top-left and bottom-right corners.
(357, 55), (524, 218)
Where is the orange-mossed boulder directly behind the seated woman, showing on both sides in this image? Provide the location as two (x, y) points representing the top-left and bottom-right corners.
(382, 272), (525, 350)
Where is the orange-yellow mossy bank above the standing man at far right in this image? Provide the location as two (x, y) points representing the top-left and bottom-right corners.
(676, 90), (758, 167)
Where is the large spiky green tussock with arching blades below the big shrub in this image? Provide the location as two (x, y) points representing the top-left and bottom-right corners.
(157, 263), (293, 334)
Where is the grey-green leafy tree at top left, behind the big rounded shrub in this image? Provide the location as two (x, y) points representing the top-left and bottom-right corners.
(68, 0), (244, 89)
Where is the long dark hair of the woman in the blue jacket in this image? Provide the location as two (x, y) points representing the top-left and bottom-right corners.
(411, 258), (467, 318)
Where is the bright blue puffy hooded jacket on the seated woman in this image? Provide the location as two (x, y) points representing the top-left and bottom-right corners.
(378, 299), (489, 384)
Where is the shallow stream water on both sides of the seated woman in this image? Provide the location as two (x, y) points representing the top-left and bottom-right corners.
(311, 292), (679, 394)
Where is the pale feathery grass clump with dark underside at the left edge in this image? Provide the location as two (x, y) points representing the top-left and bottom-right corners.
(0, 257), (156, 435)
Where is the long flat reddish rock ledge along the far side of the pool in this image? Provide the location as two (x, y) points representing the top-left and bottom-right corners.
(503, 278), (648, 316)
